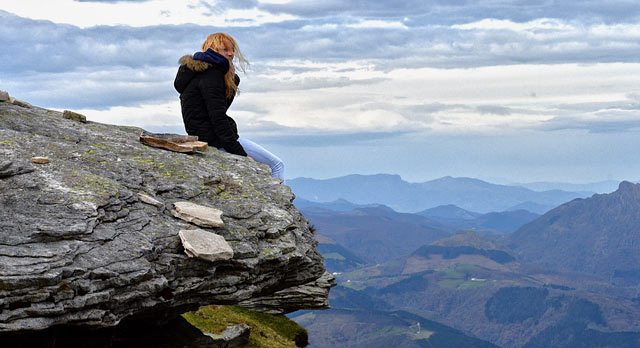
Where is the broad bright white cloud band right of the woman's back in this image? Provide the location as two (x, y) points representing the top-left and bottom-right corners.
(230, 62), (640, 134)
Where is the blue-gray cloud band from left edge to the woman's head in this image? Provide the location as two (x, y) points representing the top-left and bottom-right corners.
(0, 10), (211, 75)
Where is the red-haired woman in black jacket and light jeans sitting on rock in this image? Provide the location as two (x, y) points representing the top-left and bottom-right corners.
(173, 33), (284, 181)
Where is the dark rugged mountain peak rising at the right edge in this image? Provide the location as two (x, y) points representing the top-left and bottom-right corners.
(508, 181), (640, 277)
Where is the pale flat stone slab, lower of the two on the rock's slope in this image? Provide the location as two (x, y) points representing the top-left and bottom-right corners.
(178, 229), (233, 261)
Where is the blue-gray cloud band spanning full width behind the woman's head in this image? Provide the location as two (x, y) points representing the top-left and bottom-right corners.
(0, 7), (640, 74)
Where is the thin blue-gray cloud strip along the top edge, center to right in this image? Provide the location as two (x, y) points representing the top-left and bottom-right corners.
(260, 0), (640, 27)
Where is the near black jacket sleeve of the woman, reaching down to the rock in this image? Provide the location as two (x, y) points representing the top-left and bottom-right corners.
(200, 74), (247, 156)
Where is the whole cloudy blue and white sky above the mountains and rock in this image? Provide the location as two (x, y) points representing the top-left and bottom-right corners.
(0, 0), (640, 183)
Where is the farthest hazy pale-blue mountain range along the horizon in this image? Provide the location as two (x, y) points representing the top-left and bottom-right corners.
(287, 174), (593, 213)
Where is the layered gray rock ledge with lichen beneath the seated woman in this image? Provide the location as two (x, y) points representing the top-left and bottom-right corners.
(0, 103), (328, 334)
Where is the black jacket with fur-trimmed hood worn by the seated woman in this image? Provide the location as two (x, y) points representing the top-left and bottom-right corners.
(173, 51), (247, 156)
